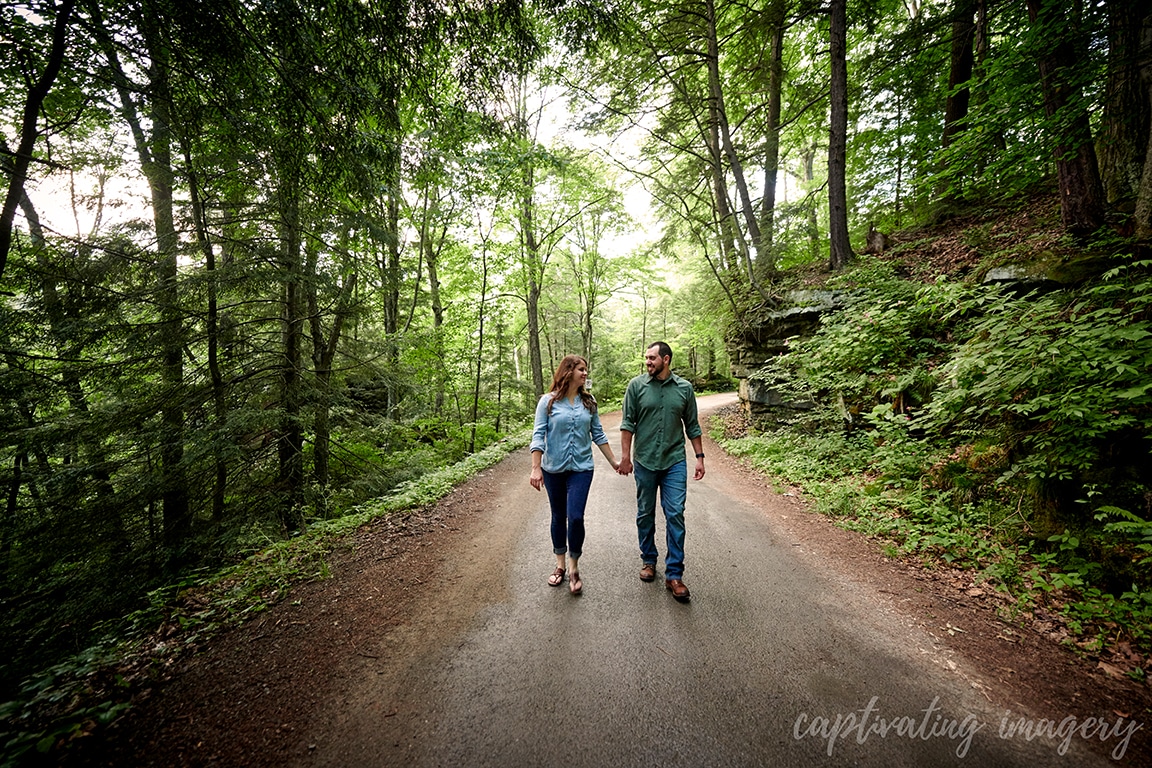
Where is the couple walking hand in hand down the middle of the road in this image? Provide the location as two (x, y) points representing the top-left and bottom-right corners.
(529, 341), (704, 602)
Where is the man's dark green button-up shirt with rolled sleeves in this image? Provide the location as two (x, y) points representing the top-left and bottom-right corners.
(620, 373), (702, 470)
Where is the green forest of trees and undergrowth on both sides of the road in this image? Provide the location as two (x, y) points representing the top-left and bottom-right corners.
(0, 0), (1152, 755)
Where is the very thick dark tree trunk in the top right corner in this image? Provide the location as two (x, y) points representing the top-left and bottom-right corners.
(1097, 0), (1152, 204)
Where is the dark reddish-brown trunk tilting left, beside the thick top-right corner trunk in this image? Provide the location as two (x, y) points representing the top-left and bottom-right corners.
(1028, 0), (1104, 236)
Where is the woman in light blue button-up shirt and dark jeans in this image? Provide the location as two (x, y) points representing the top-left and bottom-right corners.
(528, 355), (620, 594)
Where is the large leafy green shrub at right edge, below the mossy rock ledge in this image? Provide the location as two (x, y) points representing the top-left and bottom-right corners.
(926, 262), (1152, 523)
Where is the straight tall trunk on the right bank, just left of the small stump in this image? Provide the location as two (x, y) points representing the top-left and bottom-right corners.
(828, 0), (852, 271)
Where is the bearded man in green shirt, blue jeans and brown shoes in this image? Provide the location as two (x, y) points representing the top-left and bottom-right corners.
(616, 341), (704, 602)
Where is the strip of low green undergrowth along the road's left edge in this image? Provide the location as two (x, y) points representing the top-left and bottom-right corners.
(0, 431), (531, 768)
